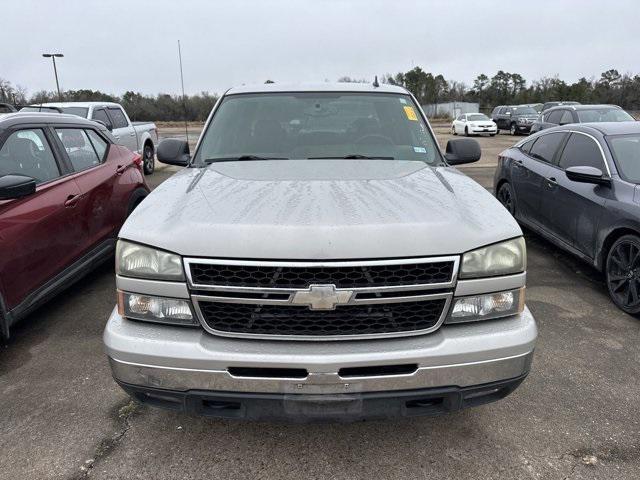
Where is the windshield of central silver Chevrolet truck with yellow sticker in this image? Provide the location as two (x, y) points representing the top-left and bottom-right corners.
(194, 92), (442, 166)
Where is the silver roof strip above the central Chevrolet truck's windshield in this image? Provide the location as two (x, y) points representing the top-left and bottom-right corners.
(226, 82), (408, 95)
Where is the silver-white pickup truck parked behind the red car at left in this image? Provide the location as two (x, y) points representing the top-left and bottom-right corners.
(20, 102), (158, 175)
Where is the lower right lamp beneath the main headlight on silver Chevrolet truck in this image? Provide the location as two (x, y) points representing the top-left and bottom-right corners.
(445, 288), (524, 323)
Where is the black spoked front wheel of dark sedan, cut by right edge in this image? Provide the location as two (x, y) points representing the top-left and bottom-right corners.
(605, 235), (640, 315)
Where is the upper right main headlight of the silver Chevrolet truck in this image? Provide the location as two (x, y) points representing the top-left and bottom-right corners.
(459, 237), (527, 278)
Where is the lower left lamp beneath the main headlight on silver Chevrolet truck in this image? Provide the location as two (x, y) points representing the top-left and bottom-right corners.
(118, 291), (198, 326)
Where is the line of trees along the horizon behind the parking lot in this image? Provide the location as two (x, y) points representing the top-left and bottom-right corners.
(0, 67), (640, 121)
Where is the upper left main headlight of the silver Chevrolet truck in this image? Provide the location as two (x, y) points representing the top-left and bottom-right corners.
(116, 240), (184, 281)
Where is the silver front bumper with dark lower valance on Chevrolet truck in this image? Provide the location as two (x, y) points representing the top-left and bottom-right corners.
(104, 308), (537, 421)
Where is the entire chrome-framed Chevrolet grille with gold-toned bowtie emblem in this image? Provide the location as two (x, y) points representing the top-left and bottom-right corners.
(184, 256), (460, 340)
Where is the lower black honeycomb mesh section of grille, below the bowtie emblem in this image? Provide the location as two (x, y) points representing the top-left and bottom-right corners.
(200, 299), (446, 336)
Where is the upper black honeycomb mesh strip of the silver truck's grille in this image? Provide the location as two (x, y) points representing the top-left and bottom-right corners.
(191, 261), (453, 288)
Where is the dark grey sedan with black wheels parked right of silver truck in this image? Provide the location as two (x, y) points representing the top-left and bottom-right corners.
(495, 122), (640, 314)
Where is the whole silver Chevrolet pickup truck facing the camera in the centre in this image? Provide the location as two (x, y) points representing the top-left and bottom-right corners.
(104, 83), (537, 421)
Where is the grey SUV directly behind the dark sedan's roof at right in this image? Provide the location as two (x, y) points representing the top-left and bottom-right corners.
(531, 105), (635, 133)
